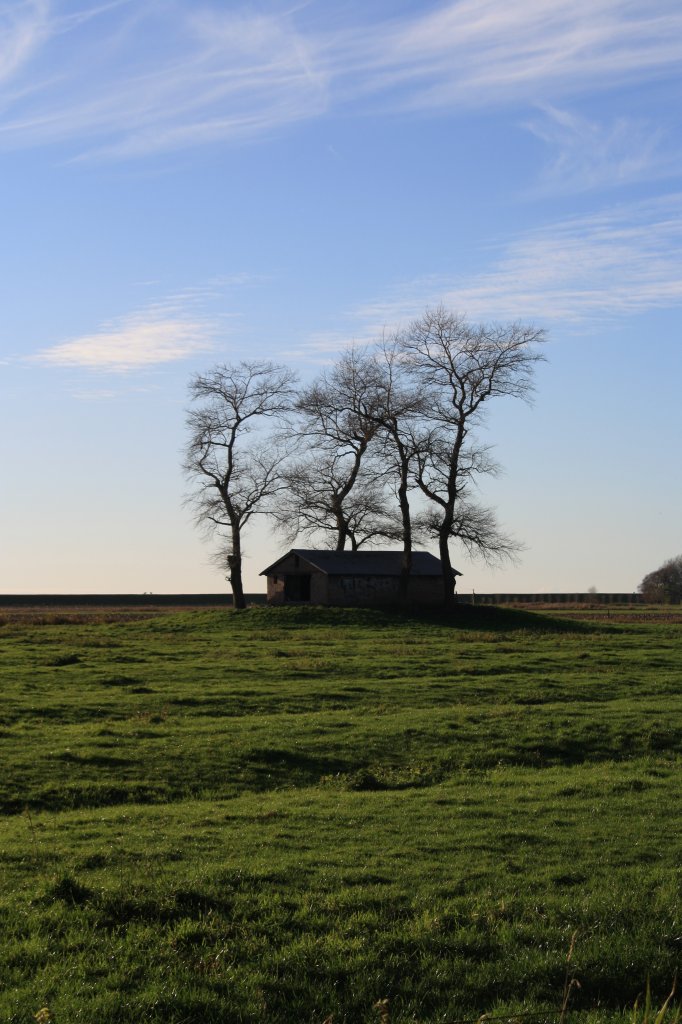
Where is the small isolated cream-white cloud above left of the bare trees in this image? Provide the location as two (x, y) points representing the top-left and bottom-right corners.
(33, 302), (216, 373)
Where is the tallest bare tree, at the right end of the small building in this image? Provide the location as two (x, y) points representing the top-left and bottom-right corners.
(399, 306), (545, 604)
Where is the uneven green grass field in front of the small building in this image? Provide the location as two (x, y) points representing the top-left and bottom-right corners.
(0, 607), (682, 1024)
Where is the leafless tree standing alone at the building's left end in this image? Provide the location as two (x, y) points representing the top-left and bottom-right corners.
(184, 362), (296, 608)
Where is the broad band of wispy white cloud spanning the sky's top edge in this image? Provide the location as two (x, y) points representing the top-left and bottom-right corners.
(0, 0), (682, 158)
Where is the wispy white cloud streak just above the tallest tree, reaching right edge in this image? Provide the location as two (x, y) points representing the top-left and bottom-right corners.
(346, 195), (682, 331)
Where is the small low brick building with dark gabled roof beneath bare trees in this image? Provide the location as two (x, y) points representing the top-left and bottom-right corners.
(260, 548), (461, 607)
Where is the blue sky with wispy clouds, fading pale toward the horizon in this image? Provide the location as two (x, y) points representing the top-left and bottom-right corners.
(0, 0), (682, 593)
